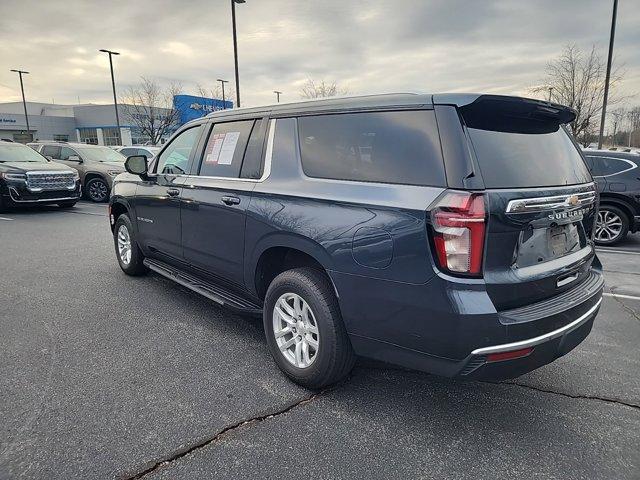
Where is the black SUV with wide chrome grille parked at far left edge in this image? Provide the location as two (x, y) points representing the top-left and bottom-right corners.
(0, 142), (81, 211)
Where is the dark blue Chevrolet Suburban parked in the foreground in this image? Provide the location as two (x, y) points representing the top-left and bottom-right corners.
(110, 94), (603, 388)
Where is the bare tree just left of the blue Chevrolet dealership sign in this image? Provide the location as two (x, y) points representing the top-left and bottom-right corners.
(122, 77), (182, 145)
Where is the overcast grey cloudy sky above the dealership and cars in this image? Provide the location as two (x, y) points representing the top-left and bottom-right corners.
(0, 0), (640, 106)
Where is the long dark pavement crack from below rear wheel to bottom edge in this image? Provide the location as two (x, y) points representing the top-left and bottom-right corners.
(117, 388), (336, 480)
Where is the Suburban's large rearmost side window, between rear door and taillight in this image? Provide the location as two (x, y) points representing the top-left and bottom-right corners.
(298, 110), (446, 186)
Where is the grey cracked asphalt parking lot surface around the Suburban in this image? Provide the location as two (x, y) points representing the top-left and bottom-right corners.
(0, 203), (640, 479)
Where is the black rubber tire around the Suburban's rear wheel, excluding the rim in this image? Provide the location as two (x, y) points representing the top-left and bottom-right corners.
(263, 267), (355, 389)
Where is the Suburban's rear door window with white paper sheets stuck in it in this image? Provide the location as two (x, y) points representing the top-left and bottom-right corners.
(199, 120), (255, 178)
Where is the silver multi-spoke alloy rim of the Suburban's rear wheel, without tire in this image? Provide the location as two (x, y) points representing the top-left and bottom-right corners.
(273, 293), (320, 368)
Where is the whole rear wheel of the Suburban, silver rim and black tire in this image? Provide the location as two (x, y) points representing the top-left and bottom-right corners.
(263, 268), (355, 389)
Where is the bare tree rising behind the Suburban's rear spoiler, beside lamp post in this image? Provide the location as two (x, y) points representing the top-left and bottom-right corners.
(531, 45), (624, 146)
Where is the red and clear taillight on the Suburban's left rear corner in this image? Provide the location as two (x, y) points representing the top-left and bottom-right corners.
(431, 192), (486, 275)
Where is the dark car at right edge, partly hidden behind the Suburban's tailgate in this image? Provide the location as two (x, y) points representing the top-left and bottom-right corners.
(583, 150), (640, 245)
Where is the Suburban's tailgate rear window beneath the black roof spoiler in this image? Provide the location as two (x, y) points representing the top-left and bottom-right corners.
(462, 102), (592, 188)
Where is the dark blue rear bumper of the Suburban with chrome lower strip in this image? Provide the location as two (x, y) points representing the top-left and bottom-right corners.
(334, 268), (604, 380)
